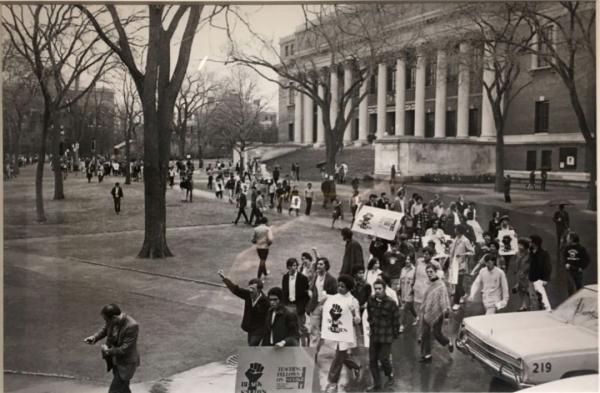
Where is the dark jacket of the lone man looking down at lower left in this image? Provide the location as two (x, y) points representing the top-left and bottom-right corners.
(94, 314), (140, 380)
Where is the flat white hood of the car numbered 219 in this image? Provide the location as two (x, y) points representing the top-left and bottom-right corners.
(464, 311), (598, 358)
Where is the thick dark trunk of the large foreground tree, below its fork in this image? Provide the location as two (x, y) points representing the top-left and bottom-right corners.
(138, 110), (173, 259)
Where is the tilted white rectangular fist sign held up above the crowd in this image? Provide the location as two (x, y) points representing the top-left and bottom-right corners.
(352, 206), (404, 240)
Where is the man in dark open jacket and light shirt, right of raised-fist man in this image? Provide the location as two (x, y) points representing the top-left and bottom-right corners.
(281, 258), (309, 346)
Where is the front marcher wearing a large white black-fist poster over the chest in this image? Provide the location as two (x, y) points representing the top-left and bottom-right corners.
(321, 274), (360, 392)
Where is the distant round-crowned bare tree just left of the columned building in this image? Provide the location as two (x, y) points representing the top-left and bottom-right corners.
(209, 68), (266, 170)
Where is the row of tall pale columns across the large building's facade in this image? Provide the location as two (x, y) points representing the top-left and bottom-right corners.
(294, 43), (496, 144)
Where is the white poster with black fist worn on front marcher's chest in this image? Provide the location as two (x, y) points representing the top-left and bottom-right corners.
(321, 295), (354, 343)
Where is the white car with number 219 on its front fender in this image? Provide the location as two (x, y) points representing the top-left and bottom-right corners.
(456, 285), (598, 389)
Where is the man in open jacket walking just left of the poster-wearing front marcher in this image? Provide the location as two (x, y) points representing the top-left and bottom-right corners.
(306, 258), (337, 352)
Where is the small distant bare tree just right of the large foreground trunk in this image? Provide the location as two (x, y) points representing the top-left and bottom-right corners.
(173, 73), (214, 158)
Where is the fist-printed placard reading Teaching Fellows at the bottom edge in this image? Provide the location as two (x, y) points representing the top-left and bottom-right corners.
(235, 347), (315, 393)
